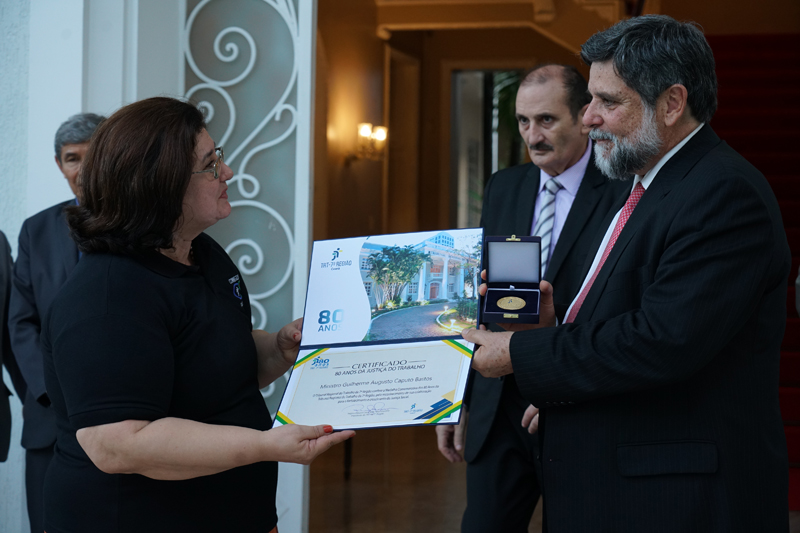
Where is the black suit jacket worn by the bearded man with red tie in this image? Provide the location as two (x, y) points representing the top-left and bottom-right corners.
(510, 126), (791, 533)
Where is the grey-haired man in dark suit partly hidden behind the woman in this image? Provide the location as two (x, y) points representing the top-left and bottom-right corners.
(8, 113), (104, 533)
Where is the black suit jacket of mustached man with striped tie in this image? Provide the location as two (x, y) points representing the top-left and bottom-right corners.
(465, 154), (631, 461)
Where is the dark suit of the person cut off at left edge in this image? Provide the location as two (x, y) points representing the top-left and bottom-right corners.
(0, 231), (25, 462)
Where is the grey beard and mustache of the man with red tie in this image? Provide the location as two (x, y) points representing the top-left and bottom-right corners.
(589, 106), (662, 180)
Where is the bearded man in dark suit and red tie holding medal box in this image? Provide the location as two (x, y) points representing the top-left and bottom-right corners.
(464, 15), (791, 533)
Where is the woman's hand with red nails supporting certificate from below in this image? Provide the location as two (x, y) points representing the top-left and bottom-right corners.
(264, 424), (356, 465)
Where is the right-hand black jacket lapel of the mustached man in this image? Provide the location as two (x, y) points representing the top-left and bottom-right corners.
(545, 154), (607, 281)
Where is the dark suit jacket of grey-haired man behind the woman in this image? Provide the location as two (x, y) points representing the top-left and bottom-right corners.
(9, 200), (78, 450)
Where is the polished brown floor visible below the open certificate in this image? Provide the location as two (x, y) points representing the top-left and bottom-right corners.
(309, 427), (800, 533)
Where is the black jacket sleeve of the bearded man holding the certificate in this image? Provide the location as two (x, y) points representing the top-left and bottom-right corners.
(510, 158), (788, 405)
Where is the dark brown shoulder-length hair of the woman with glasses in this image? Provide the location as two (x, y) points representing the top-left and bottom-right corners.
(67, 97), (205, 254)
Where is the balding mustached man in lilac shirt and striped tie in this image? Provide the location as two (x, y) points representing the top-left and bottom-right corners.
(436, 65), (629, 533)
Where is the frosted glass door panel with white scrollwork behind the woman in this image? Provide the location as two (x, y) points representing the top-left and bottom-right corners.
(183, 0), (299, 406)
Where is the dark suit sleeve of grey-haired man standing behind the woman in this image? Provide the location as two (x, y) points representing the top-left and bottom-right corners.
(8, 221), (49, 405)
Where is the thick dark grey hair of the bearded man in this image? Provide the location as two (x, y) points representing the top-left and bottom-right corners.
(581, 15), (717, 122)
